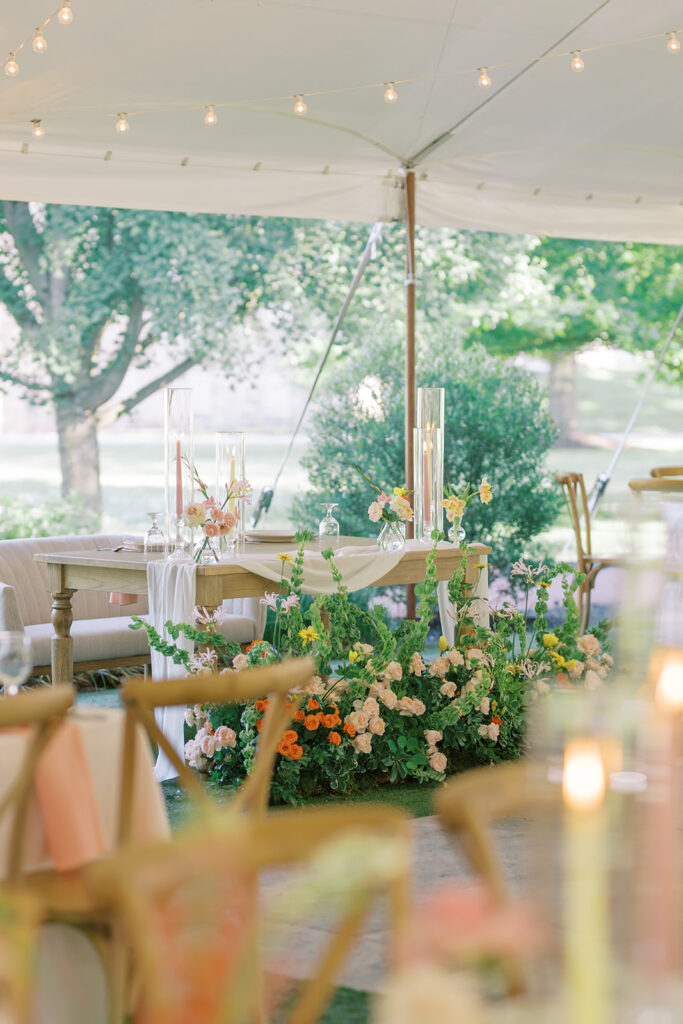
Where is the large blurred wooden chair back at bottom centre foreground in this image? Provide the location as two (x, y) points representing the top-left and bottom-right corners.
(90, 805), (411, 1024)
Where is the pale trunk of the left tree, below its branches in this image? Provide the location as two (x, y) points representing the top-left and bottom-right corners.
(55, 402), (102, 511)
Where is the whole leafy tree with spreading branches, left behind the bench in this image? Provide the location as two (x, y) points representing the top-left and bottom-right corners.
(0, 202), (301, 508)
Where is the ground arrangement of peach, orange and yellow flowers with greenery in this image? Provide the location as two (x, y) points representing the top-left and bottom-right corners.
(133, 535), (613, 804)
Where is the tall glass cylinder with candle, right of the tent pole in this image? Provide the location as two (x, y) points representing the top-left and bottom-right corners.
(414, 387), (445, 541)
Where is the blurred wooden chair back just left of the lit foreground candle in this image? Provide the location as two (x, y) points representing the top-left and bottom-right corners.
(434, 759), (561, 995)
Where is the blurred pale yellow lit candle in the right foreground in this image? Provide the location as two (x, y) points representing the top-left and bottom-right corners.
(562, 739), (612, 1024)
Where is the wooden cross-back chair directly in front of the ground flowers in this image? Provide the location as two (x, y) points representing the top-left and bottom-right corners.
(119, 658), (314, 843)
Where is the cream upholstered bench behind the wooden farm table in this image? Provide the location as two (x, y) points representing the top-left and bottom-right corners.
(0, 534), (264, 675)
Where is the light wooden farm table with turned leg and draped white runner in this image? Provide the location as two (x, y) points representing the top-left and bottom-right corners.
(34, 537), (492, 683)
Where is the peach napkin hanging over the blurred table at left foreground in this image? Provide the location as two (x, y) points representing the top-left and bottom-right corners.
(35, 721), (106, 871)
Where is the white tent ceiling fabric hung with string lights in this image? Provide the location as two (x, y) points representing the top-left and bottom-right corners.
(0, 0), (683, 244)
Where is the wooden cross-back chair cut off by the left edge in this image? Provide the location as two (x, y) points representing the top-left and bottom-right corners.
(0, 686), (74, 1024)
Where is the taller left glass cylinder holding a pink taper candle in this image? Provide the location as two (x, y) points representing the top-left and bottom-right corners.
(165, 387), (195, 561)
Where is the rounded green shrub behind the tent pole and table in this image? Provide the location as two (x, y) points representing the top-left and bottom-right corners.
(292, 336), (560, 566)
